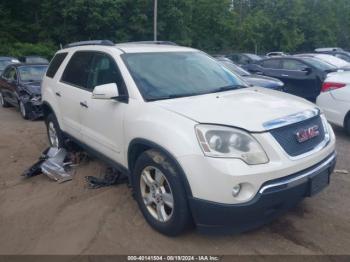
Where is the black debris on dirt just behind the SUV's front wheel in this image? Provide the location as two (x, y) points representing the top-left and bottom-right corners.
(85, 167), (128, 189)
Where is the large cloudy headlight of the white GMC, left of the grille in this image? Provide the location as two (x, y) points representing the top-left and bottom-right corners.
(195, 125), (269, 165)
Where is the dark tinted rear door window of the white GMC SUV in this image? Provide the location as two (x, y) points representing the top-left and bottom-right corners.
(61, 51), (94, 89)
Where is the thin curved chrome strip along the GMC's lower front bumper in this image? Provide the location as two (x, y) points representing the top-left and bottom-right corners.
(259, 153), (336, 194)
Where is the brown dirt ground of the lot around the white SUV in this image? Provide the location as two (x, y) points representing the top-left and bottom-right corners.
(0, 105), (350, 255)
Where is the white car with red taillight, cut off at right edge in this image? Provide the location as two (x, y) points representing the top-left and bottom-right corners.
(317, 72), (350, 135)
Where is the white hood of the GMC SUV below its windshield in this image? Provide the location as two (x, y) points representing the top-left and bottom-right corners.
(153, 87), (316, 132)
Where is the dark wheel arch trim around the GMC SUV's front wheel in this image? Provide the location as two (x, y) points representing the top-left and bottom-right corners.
(127, 138), (192, 197)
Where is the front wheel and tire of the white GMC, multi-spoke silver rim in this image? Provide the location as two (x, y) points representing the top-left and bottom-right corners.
(133, 149), (192, 236)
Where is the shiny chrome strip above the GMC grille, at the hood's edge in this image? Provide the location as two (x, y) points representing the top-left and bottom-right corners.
(263, 108), (320, 131)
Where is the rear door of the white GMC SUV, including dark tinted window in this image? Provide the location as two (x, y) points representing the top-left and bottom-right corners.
(56, 51), (93, 140)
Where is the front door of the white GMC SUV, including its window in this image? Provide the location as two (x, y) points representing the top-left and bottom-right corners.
(81, 52), (128, 163)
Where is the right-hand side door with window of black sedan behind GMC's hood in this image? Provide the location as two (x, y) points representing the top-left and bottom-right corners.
(279, 58), (320, 102)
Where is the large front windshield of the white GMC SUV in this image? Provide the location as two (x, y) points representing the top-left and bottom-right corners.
(123, 52), (246, 101)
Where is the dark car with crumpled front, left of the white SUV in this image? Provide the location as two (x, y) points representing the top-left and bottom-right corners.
(0, 64), (47, 119)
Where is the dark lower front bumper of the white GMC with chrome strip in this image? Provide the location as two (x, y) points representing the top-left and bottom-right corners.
(189, 152), (336, 233)
